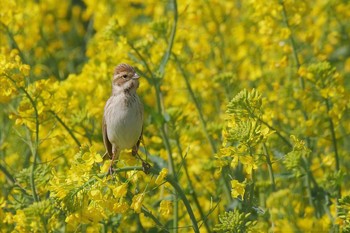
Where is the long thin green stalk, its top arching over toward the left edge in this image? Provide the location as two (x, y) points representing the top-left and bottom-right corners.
(5, 75), (39, 202)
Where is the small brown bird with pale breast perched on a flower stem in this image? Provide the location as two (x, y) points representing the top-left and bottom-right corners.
(102, 64), (143, 172)
